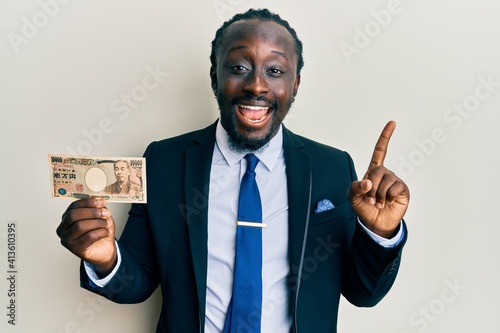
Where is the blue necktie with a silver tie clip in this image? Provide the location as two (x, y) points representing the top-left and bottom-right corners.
(223, 154), (262, 333)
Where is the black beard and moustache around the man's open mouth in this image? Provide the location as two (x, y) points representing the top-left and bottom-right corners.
(217, 95), (292, 154)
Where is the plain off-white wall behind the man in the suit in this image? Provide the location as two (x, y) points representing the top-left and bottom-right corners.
(0, 0), (500, 333)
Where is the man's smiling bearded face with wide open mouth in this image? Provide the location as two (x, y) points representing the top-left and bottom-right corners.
(210, 20), (300, 151)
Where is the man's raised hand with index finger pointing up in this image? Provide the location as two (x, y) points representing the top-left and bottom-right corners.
(347, 121), (410, 238)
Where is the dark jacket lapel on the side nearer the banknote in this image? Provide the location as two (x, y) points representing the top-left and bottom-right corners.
(184, 121), (216, 327)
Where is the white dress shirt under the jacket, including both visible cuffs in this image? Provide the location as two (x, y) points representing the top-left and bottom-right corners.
(85, 122), (403, 333)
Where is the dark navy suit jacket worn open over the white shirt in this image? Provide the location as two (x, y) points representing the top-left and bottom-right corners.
(81, 120), (406, 333)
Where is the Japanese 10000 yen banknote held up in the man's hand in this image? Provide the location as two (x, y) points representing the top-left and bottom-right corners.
(49, 154), (147, 203)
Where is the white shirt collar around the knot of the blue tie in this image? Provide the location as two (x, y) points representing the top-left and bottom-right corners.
(215, 120), (283, 171)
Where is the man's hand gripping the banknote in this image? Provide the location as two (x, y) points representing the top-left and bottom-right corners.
(57, 198), (117, 278)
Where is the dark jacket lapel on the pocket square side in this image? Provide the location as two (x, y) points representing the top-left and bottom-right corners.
(283, 128), (311, 292)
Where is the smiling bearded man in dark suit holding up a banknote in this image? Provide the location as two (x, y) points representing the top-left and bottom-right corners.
(57, 10), (409, 333)
